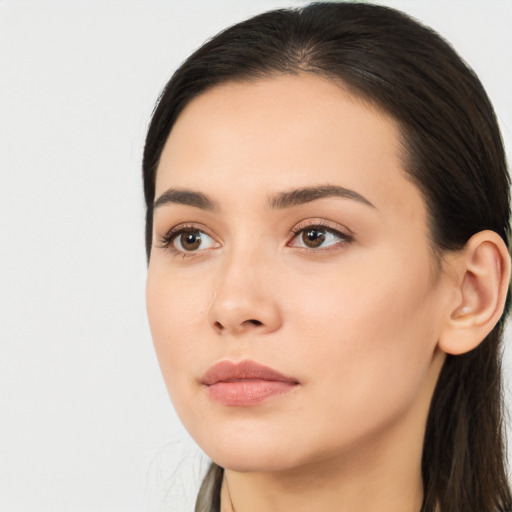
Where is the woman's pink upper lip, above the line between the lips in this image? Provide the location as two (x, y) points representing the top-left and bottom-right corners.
(201, 360), (298, 386)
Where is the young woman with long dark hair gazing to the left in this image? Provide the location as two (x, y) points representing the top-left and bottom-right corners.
(143, 3), (512, 512)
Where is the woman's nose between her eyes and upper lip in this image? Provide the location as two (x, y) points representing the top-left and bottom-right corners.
(208, 248), (282, 336)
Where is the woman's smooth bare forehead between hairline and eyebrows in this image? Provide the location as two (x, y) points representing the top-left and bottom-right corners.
(156, 74), (423, 222)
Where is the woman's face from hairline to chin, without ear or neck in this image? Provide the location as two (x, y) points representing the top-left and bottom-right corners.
(147, 75), (446, 471)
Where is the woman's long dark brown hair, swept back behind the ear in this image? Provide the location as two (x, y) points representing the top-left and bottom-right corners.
(143, 2), (512, 512)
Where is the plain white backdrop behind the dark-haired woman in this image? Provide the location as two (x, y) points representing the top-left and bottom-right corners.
(0, 0), (512, 512)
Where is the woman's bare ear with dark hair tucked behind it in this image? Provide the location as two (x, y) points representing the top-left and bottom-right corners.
(438, 231), (510, 355)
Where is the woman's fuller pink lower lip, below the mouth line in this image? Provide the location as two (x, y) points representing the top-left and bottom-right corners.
(208, 380), (297, 407)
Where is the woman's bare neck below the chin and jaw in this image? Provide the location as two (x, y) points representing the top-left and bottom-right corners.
(221, 438), (423, 512)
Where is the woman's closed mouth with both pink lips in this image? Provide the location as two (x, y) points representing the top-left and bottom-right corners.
(201, 360), (300, 407)
